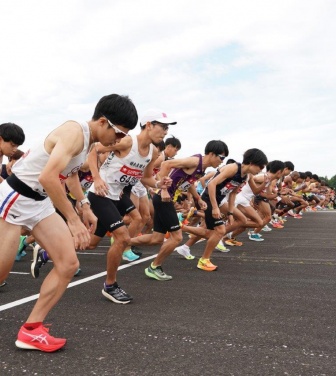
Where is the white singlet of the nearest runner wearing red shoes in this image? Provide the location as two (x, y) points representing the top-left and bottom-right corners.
(12, 122), (90, 197)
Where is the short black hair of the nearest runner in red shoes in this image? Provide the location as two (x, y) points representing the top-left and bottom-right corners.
(92, 94), (138, 129)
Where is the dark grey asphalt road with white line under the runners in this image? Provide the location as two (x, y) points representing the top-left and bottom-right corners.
(0, 211), (336, 376)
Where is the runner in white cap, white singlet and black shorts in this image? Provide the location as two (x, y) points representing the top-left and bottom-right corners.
(88, 110), (176, 304)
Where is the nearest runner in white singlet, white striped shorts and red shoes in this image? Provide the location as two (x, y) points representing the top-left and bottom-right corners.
(0, 94), (138, 352)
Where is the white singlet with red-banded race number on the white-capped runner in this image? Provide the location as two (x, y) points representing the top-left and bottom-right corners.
(89, 136), (154, 200)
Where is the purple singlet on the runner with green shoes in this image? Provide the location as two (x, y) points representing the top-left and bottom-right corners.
(168, 154), (204, 201)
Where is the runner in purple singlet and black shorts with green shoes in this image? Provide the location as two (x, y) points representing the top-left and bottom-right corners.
(130, 140), (229, 281)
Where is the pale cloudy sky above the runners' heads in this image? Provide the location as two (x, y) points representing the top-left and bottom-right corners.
(0, 0), (336, 178)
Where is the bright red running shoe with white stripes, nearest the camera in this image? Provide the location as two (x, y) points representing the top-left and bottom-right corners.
(15, 325), (66, 352)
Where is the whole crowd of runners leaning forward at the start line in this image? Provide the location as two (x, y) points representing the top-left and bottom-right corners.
(0, 94), (335, 352)
